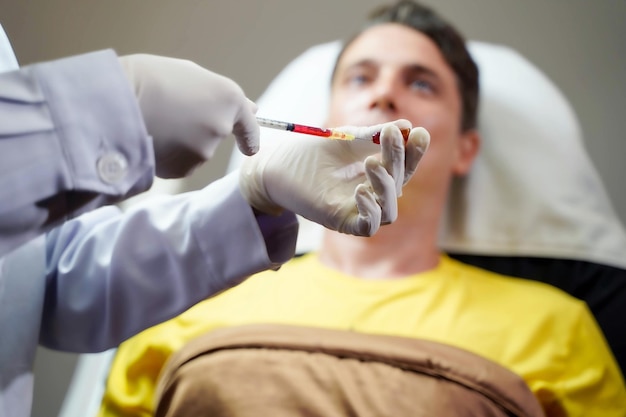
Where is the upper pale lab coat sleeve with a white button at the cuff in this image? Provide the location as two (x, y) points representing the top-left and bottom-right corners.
(0, 50), (154, 256)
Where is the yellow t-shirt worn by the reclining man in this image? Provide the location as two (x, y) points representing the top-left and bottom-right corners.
(100, 255), (626, 417)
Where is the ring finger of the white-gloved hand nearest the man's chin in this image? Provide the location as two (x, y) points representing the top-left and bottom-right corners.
(365, 156), (398, 224)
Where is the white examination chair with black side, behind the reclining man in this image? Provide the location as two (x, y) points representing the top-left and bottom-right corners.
(61, 42), (626, 417)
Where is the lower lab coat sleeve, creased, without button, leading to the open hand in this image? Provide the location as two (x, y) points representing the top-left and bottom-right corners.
(40, 172), (298, 352)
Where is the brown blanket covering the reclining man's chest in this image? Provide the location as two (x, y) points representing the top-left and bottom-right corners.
(156, 325), (544, 417)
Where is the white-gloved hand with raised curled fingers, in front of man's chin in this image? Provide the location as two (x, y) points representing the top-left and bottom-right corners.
(239, 120), (430, 236)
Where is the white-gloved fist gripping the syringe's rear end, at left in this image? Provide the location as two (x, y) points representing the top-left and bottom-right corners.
(119, 54), (259, 178)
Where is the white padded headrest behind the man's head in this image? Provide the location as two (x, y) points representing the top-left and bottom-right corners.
(230, 41), (626, 268)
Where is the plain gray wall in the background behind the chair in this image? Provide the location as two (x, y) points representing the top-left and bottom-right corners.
(0, 0), (626, 416)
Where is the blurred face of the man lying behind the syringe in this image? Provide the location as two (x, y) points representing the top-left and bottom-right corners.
(327, 23), (476, 203)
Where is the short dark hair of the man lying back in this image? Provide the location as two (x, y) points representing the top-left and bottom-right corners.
(333, 0), (479, 131)
